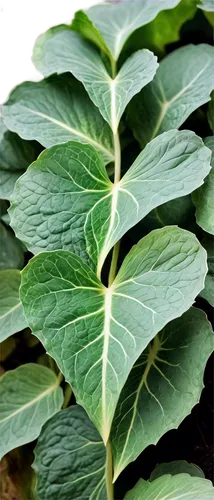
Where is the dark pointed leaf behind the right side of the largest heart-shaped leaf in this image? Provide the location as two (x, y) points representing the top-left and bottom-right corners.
(111, 308), (214, 480)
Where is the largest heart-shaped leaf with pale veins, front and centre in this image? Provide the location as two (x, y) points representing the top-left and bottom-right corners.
(20, 226), (207, 442)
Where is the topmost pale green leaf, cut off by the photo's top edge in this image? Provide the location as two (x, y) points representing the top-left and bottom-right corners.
(87, 0), (180, 61)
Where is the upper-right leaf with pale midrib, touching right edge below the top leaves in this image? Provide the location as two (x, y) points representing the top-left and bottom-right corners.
(127, 44), (214, 147)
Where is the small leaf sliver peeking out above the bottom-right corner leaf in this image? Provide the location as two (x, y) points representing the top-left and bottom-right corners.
(149, 460), (205, 482)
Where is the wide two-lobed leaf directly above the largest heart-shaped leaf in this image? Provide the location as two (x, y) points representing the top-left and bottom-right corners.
(9, 130), (211, 276)
